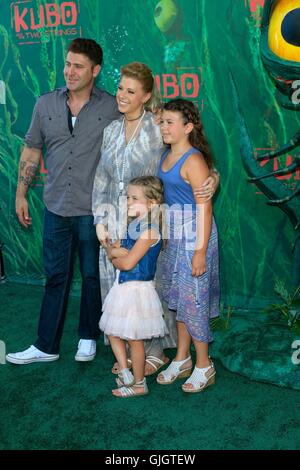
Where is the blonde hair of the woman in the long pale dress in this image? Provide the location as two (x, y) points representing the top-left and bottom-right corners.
(121, 62), (162, 113)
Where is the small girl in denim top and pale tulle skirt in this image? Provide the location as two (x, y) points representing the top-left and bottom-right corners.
(99, 176), (168, 398)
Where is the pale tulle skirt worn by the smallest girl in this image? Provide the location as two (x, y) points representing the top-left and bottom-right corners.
(99, 276), (168, 340)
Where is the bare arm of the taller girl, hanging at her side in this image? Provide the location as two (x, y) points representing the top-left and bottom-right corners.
(182, 153), (212, 276)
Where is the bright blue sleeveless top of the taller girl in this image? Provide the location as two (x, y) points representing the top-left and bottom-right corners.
(157, 147), (200, 209)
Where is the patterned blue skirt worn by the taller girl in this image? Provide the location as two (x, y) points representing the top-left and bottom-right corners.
(161, 214), (220, 343)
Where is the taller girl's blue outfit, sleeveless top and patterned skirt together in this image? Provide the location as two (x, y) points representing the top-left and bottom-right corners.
(158, 148), (220, 343)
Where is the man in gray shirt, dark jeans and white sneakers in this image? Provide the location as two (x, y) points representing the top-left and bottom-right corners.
(6, 38), (119, 364)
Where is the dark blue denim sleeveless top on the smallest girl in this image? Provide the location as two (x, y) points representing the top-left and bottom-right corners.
(118, 220), (162, 284)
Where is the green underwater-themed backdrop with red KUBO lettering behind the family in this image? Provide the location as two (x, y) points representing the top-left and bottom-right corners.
(0, 0), (300, 308)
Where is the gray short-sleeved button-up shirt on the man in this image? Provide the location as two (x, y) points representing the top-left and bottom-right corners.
(25, 87), (120, 217)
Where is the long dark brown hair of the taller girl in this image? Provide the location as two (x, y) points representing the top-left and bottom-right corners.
(163, 98), (213, 169)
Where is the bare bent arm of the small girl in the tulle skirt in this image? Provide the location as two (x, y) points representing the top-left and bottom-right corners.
(112, 229), (159, 271)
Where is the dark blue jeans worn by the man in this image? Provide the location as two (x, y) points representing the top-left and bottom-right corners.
(34, 209), (101, 354)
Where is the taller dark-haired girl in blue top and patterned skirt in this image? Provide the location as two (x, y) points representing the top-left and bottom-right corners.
(157, 99), (219, 393)
